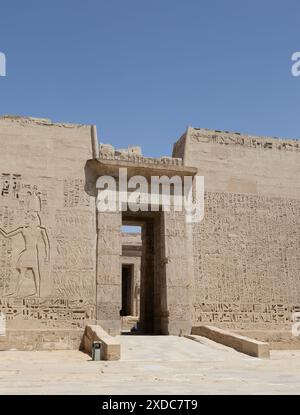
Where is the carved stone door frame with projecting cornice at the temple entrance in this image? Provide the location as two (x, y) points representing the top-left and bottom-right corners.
(90, 158), (196, 335)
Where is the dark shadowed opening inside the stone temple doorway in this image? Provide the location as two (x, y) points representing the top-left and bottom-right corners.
(122, 212), (168, 334)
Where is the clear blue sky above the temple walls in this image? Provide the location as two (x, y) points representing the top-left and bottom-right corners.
(0, 0), (300, 156)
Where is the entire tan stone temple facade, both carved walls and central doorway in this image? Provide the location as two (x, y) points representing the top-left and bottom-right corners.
(0, 117), (300, 349)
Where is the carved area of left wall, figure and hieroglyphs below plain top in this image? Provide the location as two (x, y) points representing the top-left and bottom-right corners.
(0, 172), (95, 328)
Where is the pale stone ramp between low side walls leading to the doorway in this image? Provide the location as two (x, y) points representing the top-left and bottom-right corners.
(117, 335), (248, 362)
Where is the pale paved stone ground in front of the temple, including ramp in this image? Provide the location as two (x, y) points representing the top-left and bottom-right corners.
(0, 336), (300, 394)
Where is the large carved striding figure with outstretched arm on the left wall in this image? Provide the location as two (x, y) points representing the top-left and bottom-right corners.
(0, 211), (50, 296)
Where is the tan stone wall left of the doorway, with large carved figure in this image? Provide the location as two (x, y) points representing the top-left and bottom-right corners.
(0, 117), (96, 349)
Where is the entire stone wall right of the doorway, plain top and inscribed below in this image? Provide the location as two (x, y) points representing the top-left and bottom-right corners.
(173, 128), (300, 338)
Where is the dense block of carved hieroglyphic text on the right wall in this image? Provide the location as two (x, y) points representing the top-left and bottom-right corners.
(194, 193), (300, 326)
